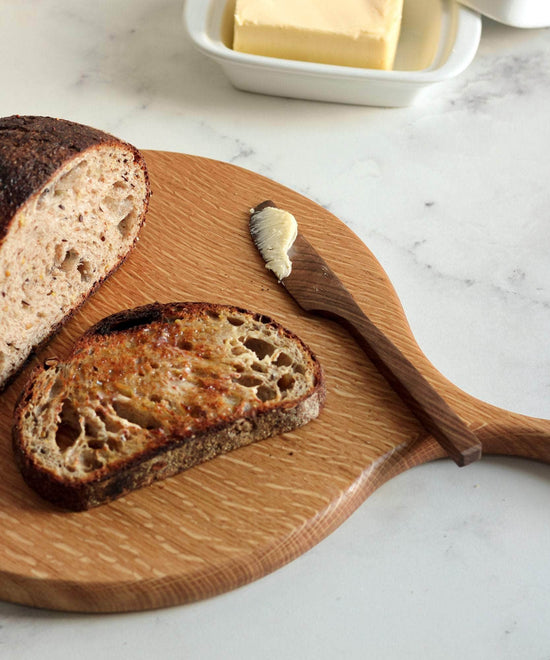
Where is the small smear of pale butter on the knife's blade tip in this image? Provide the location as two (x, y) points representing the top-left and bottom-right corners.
(250, 206), (298, 281)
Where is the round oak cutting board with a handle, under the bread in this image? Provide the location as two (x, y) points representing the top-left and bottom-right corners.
(0, 151), (550, 612)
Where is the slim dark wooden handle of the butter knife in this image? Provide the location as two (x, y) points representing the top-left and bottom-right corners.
(317, 302), (482, 467)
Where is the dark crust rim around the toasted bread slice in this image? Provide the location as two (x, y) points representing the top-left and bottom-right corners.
(13, 302), (326, 511)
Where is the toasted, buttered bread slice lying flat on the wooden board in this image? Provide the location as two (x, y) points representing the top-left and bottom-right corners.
(13, 303), (325, 510)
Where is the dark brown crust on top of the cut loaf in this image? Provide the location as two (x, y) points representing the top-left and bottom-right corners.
(0, 115), (149, 241)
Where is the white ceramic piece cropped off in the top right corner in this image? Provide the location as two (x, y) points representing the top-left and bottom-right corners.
(462, 0), (550, 28)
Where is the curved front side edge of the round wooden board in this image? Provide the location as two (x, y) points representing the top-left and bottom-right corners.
(0, 434), (444, 614)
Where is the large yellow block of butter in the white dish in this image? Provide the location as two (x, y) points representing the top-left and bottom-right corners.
(233, 0), (403, 70)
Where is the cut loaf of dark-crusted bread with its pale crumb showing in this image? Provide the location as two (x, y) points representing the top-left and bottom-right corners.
(0, 116), (150, 389)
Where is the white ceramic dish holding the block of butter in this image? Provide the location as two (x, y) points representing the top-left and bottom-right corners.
(183, 0), (484, 107)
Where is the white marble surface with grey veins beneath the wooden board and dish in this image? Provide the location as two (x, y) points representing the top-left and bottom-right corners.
(0, 0), (550, 660)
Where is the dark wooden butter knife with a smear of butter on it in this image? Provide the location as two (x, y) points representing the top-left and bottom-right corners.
(250, 200), (481, 466)
